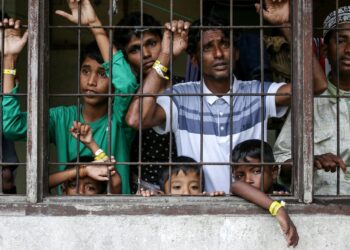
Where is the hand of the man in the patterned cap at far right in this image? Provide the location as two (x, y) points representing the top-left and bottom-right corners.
(314, 153), (346, 173)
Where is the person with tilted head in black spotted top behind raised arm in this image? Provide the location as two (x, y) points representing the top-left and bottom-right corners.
(114, 12), (189, 191)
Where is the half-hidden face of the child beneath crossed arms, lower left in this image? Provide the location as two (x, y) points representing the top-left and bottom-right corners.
(64, 177), (102, 195)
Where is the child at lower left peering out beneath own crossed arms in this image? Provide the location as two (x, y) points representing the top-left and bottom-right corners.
(49, 122), (121, 195)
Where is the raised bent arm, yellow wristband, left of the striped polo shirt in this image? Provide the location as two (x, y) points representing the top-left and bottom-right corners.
(126, 20), (190, 129)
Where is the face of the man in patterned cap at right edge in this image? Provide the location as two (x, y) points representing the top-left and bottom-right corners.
(325, 23), (350, 75)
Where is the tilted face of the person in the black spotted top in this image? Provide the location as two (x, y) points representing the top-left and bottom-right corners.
(125, 32), (161, 75)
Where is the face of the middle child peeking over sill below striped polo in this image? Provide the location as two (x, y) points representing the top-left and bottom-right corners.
(164, 170), (201, 195)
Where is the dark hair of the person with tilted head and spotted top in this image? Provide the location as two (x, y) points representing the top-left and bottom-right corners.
(113, 12), (162, 52)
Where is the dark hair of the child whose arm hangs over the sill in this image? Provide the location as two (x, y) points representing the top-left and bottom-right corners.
(232, 140), (275, 162)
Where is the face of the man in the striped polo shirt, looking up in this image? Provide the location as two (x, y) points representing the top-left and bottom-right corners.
(195, 30), (239, 81)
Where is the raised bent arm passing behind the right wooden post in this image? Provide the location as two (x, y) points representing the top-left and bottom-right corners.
(255, 0), (327, 106)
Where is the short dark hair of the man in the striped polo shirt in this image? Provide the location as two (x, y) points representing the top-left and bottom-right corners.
(186, 17), (238, 56)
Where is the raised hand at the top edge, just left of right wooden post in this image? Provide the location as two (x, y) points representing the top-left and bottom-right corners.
(255, 0), (289, 25)
